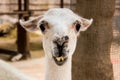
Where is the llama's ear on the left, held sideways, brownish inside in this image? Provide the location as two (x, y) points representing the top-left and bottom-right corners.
(19, 16), (42, 32)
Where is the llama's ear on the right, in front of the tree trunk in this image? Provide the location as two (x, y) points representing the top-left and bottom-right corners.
(80, 18), (93, 31)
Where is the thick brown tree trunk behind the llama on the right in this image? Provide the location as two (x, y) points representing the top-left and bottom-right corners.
(73, 0), (115, 80)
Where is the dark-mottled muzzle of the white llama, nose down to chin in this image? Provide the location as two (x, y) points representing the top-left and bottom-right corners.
(53, 36), (69, 65)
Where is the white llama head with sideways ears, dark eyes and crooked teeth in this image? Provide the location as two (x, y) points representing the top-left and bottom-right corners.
(20, 8), (93, 66)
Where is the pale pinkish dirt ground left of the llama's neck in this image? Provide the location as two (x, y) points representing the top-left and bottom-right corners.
(10, 58), (45, 80)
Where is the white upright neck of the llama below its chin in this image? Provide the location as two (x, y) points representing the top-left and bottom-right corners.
(45, 58), (71, 80)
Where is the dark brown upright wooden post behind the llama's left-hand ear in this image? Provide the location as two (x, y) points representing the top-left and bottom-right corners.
(17, 0), (30, 59)
